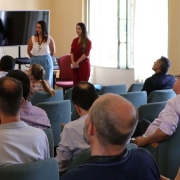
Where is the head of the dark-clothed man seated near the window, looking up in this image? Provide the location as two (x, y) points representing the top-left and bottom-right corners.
(152, 56), (171, 73)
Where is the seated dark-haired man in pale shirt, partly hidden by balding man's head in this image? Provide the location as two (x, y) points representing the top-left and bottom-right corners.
(56, 81), (98, 174)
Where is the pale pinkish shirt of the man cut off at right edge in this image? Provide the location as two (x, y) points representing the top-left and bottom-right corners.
(143, 95), (180, 137)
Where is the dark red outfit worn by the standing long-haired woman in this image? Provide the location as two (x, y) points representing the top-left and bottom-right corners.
(71, 37), (91, 86)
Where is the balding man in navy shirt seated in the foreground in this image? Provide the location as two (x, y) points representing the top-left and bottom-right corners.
(61, 94), (160, 180)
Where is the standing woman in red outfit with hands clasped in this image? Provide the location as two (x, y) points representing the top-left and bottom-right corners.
(71, 22), (91, 86)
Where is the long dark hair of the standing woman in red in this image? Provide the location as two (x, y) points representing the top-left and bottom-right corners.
(76, 22), (88, 52)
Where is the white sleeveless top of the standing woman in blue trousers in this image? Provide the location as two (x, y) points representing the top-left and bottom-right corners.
(31, 36), (50, 56)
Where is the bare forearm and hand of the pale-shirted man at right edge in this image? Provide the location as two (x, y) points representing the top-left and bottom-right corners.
(135, 128), (169, 146)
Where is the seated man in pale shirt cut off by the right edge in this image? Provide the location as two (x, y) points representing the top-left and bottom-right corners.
(135, 74), (180, 146)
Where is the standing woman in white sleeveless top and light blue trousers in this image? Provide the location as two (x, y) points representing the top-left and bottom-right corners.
(27, 21), (55, 87)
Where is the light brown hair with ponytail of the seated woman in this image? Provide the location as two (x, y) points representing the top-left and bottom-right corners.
(30, 64), (55, 96)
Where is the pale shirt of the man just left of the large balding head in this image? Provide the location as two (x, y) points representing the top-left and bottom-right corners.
(56, 115), (90, 172)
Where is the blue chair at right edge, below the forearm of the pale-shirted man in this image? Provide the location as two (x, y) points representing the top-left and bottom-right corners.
(144, 123), (180, 179)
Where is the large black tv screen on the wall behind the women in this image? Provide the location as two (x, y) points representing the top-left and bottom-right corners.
(0, 10), (50, 46)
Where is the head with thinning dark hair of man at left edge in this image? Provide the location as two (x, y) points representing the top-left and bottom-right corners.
(0, 76), (23, 116)
